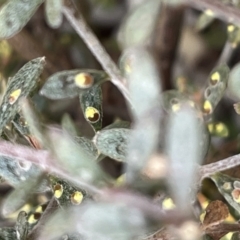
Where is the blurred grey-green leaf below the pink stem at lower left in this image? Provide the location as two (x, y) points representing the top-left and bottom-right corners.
(2, 171), (42, 216)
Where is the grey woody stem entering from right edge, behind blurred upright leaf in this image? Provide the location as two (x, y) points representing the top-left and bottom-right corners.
(200, 154), (240, 181)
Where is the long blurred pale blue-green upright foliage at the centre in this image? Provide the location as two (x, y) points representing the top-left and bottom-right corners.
(120, 47), (161, 180)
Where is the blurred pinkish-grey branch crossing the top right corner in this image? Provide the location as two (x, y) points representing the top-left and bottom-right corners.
(188, 0), (240, 24)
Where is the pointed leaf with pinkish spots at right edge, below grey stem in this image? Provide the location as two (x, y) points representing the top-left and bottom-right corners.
(211, 173), (240, 213)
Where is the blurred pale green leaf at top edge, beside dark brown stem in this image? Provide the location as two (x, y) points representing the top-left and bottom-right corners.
(118, 0), (161, 49)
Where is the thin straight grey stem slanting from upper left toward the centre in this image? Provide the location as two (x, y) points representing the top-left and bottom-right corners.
(62, 0), (130, 102)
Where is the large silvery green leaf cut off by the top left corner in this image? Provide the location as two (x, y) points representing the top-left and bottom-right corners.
(0, 0), (43, 39)
